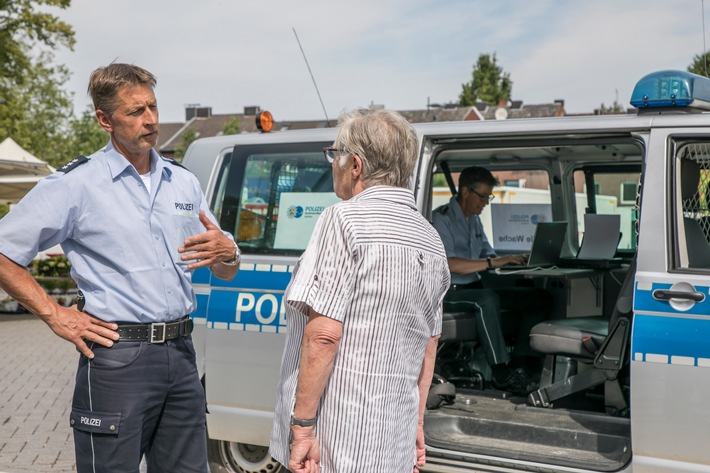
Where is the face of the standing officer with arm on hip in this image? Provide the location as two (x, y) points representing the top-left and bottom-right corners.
(96, 85), (158, 161)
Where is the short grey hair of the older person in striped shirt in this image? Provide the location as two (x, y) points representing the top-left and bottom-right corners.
(334, 108), (418, 188)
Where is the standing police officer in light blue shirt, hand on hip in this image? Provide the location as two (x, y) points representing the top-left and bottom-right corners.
(0, 64), (240, 473)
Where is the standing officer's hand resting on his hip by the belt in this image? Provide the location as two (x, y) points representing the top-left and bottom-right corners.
(45, 305), (119, 358)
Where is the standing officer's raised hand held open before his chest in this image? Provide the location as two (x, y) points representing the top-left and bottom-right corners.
(178, 210), (234, 269)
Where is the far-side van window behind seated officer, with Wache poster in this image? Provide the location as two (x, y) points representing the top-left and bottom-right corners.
(432, 169), (553, 253)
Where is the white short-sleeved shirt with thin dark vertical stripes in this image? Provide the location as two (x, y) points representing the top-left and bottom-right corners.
(271, 186), (449, 473)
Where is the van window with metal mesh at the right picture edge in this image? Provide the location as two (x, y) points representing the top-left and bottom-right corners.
(675, 143), (710, 269)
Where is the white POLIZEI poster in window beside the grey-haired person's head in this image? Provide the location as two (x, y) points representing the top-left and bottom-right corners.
(274, 192), (340, 250)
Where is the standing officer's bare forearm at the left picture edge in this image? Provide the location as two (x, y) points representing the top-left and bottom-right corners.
(0, 253), (58, 322)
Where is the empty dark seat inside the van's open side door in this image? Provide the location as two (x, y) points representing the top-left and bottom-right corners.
(528, 256), (636, 415)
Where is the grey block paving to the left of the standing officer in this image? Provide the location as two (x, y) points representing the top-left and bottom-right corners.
(0, 314), (78, 473)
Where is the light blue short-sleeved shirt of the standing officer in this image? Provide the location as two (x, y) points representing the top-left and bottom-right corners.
(0, 143), (231, 323)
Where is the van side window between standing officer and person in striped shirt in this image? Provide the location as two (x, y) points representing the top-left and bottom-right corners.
(212, 144), (340, 255)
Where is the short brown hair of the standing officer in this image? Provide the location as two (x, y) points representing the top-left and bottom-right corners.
(88, 63), (158, 116)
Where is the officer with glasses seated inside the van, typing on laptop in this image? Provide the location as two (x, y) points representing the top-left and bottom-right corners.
(433, 166), (551, 394)
